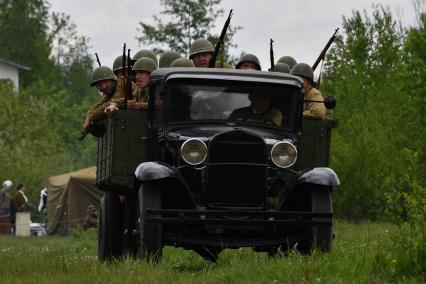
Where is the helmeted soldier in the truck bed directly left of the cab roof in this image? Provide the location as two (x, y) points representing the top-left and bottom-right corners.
(105, 57), (157, 113)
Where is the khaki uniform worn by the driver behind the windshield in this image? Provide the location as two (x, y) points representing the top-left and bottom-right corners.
(229, 107), (283, 126)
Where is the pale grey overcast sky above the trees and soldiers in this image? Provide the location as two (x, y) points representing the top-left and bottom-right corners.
(49, 0), (416, 70)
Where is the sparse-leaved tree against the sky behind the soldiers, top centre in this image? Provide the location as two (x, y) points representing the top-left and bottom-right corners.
(137, 0), (242, 61)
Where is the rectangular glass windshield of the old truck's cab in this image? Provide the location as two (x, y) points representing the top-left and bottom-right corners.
(166, 79), (300, 129)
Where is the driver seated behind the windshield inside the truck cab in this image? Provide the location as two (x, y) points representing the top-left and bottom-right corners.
(229, 94), (283, 126)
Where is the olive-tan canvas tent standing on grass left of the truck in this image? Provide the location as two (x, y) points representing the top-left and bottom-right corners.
(47, 167), (103, 235)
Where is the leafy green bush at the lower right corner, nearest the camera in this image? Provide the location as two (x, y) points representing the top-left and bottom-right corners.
(376, 153), (426, 280)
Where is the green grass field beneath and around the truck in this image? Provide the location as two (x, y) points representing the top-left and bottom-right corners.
(0, 221), (412, 283)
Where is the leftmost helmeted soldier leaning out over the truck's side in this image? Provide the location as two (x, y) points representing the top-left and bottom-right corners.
(83, 66), (117, 128)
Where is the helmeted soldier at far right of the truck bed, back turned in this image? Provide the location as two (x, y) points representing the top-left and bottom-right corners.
(290, 63), (326, 119)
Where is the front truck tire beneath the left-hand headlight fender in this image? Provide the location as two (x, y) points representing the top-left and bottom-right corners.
(138, 183), (163, 262)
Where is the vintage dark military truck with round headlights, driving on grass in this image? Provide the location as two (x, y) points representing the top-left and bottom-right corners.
(97, 68), (339, 261)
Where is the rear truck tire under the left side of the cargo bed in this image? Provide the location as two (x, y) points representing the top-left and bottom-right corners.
(98, 192), (123, 262)
